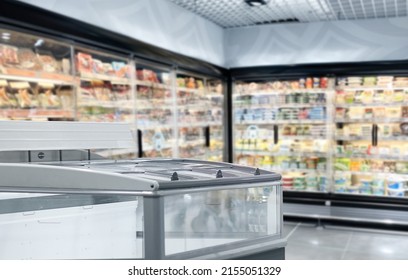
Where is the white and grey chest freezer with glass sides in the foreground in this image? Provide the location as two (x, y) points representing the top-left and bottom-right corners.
(0, 159), (286, 259)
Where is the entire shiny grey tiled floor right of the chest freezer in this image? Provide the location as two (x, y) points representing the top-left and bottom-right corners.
(283, 223), (408, 260)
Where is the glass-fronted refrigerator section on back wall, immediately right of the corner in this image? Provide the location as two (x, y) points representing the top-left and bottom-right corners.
(233, 77), (331, 192)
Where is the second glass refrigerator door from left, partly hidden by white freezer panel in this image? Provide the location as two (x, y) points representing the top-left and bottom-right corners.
(75, 46), (136, 159)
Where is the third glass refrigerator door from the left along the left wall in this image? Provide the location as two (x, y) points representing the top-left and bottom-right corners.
(136, 62), (176, 158)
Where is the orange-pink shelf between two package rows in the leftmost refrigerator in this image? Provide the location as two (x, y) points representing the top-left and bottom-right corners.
(0, 68), (75, 85)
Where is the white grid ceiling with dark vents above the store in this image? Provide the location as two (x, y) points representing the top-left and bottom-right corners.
(168, 0), (408, 28)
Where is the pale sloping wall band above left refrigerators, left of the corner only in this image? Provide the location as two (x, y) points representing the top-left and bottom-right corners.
(20, 0), (224, 66)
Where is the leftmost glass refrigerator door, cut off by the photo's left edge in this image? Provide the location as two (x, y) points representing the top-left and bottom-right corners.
(0, 28), (75, 121)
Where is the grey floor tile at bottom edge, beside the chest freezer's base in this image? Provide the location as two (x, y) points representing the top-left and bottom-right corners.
(285, 242), (344, 260)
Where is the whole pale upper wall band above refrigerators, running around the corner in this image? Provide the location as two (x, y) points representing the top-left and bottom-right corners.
(14, 0), (408, 67)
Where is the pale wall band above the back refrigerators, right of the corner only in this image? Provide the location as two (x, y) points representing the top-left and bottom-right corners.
(224, 18), (408, 67)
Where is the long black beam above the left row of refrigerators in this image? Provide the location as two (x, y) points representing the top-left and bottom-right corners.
(0, 0), (228, 76)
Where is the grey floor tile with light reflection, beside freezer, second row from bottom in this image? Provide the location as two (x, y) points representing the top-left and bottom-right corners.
(288, 224), (352, 250)
